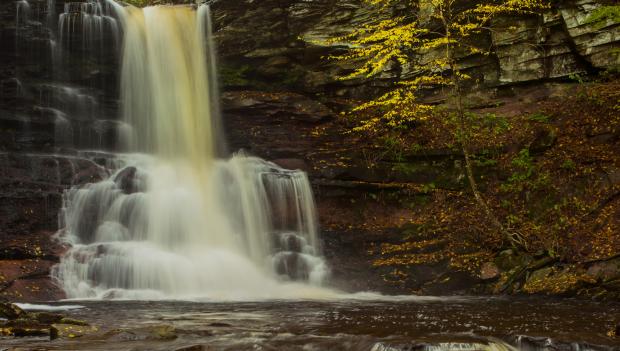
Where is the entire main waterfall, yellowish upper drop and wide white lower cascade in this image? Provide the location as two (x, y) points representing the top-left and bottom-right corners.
(53, 5), (329, 299)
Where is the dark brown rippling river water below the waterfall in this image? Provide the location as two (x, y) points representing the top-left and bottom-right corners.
(0, 297), (620, 351)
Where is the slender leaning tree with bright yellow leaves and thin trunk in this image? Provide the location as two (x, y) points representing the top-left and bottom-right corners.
(324, 0), (547, 246)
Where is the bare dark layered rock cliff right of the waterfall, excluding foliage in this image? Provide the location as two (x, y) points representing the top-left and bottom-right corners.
(213, 0), (620, 294)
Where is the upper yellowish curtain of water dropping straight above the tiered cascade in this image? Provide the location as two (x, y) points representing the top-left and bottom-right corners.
(121, 6), (215, 163)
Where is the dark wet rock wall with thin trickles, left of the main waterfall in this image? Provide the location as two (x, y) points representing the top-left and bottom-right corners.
(0, 0), (118, 300)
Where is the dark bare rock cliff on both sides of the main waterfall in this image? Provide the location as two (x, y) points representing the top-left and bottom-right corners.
(0, 0), (620, 300)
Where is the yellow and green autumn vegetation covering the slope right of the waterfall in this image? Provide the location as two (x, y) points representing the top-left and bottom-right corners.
(320, 0), (620, 294)
